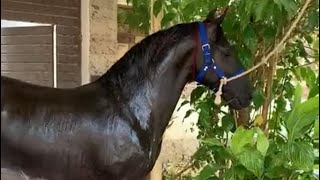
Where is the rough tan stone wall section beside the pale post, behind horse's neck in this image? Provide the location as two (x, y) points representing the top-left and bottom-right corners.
(89, 0), (118, 77)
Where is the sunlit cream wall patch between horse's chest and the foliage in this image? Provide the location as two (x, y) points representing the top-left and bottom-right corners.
(158, 84), (199, 176)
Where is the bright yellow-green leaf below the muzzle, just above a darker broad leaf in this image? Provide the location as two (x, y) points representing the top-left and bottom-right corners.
(231, 126), (255, 155)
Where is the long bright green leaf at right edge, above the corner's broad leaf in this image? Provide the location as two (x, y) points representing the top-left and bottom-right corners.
(285, 96), (319, 141)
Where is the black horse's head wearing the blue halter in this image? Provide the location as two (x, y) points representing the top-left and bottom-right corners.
(195, 10), (252, 110)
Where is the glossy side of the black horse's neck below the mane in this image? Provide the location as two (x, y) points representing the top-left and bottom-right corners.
(129, 41), (193, 144)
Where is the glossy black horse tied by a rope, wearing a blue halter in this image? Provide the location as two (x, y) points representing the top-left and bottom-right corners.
(1, 8), (251, 180)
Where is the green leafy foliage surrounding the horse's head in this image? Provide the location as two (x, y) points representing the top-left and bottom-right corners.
(119, 0), (319, 180)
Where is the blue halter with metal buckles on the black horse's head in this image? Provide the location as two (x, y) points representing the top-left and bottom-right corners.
(195, 22), (244, 91)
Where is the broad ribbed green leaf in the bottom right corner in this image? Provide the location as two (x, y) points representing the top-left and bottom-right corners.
(281, 141), (314, 171)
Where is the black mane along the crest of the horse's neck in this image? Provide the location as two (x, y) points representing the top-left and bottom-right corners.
(98, 23), (196, 86)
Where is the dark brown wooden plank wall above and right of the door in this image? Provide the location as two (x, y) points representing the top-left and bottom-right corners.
(1, 0), (81, 88)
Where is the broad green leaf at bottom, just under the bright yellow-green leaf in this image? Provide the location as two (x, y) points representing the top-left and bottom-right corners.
(237, 146), (264, 178)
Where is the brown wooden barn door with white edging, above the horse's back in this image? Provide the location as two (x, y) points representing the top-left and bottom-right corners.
(1, 26), (55, 87)
